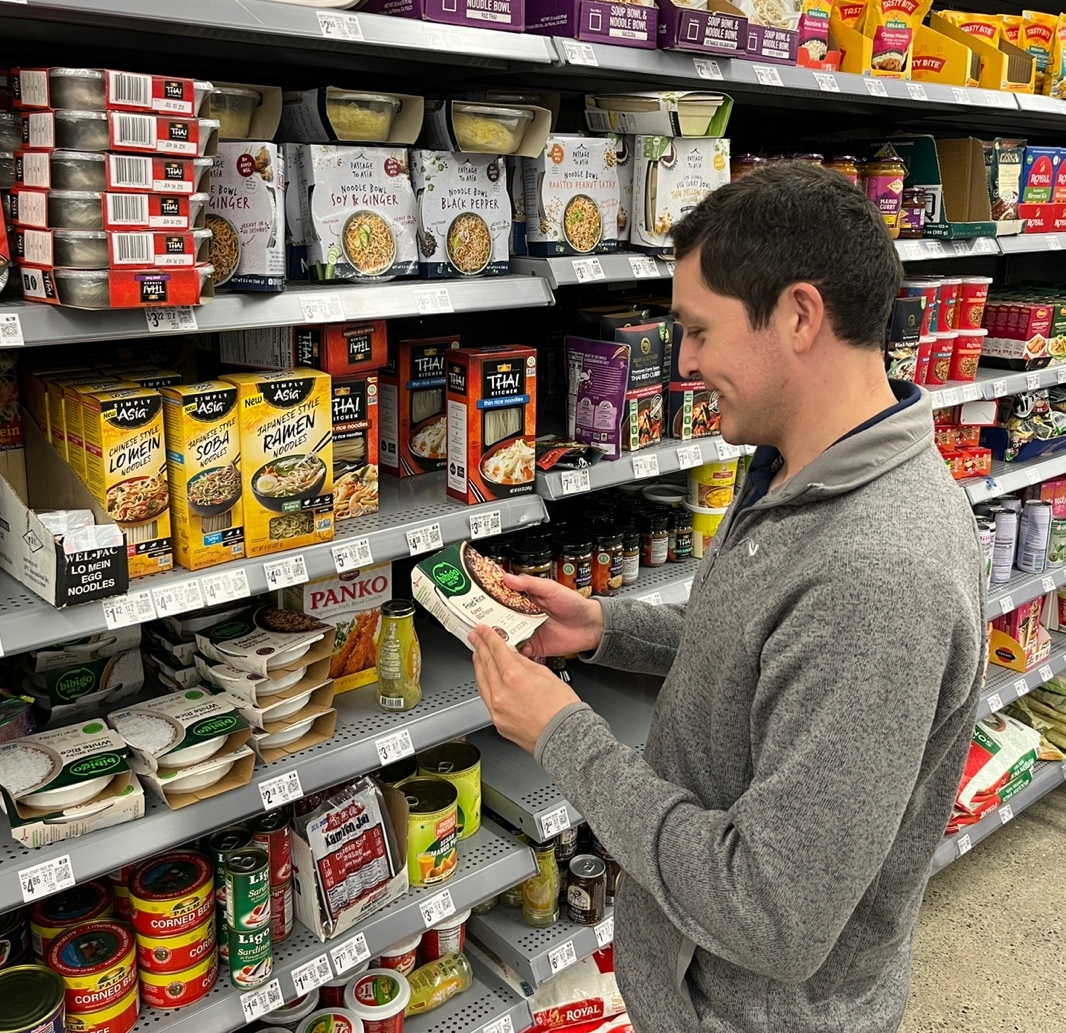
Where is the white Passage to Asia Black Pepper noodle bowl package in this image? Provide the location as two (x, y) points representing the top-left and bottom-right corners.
(410, 150), (511, 278)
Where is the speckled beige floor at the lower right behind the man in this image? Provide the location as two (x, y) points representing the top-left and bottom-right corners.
(900, 789), (1066, 1033)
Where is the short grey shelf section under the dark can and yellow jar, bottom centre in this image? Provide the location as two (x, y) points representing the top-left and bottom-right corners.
(467, 905), (614, 987)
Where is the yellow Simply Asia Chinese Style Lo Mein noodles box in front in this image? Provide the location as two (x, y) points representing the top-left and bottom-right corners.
(81, 387), (174, 578)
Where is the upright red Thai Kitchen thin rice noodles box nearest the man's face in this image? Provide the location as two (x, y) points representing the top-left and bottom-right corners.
(448, 345), (536, 505)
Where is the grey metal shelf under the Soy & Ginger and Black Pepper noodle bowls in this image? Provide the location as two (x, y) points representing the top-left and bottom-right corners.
(0, 275), (553, 345)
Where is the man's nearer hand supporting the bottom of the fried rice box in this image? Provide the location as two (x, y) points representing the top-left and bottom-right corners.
(469, 622), (584, 753)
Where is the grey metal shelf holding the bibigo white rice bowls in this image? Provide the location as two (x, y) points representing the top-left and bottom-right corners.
(0, 623), (490, 911)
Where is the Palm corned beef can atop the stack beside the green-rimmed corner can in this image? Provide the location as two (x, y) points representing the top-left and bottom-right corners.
(48, 922), (136, 1018)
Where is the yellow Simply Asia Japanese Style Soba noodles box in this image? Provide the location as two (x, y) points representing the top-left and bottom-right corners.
(160, 381), (244, 570)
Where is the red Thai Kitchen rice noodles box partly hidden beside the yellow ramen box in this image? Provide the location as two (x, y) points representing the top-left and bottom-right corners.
(333, 376), (377, 520)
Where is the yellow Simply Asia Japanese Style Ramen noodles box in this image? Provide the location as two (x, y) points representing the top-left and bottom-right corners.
(223, 370), (334, 556)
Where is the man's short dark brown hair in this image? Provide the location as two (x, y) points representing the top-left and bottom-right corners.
(673, 161), (903, 348)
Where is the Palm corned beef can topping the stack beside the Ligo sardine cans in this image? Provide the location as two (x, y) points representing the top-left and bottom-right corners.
(130, 851), (214, 937)
